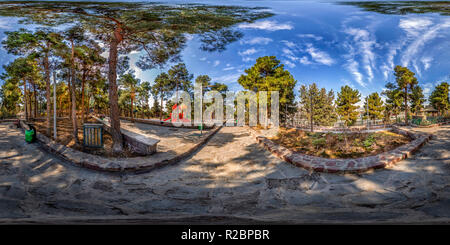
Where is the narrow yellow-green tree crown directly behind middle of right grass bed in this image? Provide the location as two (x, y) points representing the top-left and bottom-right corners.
(336, 85), (360, 126)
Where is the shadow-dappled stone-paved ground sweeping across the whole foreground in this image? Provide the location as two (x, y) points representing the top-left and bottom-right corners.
(0, 123), (450, 224)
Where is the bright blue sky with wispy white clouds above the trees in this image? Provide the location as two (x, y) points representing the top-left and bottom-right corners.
(0, 1), (450, 105)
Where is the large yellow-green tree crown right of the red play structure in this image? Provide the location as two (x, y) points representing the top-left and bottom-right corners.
(238, 56), (297, 121)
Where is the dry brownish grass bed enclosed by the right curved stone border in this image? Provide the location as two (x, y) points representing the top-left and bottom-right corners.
(271, 128), (410, 158)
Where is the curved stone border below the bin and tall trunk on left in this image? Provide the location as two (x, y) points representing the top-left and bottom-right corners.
(20, 120), (222, 173)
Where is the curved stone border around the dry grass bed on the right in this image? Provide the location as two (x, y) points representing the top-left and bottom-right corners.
(248, 126), (431, 173)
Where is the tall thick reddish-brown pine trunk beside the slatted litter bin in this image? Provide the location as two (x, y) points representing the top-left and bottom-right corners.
(108, 26), (123, 153)
